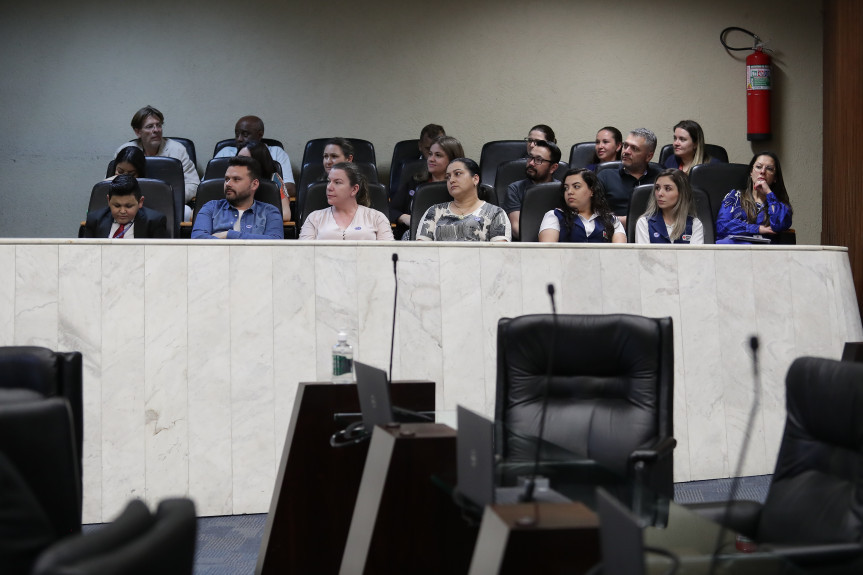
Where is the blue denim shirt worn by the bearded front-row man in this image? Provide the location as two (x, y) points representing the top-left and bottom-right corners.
(192, 200), (285, 240)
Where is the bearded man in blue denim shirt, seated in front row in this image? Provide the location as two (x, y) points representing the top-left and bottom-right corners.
(192, 156), (285, 240)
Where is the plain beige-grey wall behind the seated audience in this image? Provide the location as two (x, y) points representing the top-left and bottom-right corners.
(0, 0), (822, 243)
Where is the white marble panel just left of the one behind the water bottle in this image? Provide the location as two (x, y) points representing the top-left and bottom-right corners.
(273, 246), (317, 461)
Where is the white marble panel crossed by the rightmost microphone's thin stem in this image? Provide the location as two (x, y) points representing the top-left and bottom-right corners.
(714, 249), (775, 475)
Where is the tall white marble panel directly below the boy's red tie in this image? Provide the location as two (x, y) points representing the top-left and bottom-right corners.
(99, 243), (147, 519)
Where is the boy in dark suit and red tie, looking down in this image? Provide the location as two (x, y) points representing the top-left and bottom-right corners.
(84, 174), (170, 239)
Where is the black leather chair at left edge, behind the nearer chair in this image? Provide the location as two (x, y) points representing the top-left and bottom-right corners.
(0, 345), (84, 465)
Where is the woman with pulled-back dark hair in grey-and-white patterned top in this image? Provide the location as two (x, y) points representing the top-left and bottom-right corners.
(416, 158), (512, 242)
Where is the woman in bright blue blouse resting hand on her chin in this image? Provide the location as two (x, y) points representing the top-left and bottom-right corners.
(716, 152), (792, 244)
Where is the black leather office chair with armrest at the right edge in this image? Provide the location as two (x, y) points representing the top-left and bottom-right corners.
(687, 357), (863, 573)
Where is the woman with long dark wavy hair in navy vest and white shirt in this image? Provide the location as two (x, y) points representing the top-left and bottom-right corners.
(539, 168), (626, 244)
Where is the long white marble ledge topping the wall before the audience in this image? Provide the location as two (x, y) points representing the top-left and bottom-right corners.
(0, 238), (848, 252)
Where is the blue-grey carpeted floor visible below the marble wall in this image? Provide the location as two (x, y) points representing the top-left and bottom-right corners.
(85, 475), (772, 575)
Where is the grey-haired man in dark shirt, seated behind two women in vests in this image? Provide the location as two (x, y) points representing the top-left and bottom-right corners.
(597, 128), (660, 226)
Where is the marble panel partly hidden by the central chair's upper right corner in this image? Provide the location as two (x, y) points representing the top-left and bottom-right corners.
(639, 250), (691, 481)
